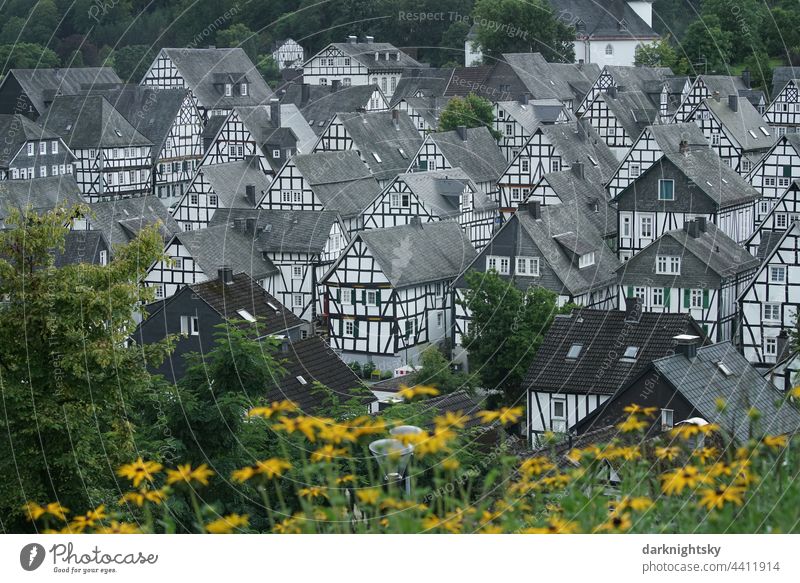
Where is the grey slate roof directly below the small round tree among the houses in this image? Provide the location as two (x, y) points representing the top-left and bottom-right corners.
(426, 126), (508, 184)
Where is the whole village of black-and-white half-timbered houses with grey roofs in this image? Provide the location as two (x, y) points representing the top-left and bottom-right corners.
(0, 2), (800, 532)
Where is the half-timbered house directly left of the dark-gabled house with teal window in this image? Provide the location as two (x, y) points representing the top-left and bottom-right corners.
(497, 120), (618, 214)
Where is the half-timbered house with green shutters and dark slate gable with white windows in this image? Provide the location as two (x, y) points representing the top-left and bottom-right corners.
(617, 218), (759, 342)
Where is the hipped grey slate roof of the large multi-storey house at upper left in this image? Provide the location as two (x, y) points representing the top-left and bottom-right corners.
(39, 95), (153, 149)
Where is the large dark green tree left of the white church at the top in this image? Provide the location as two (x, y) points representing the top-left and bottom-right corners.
(472, 0), (575, 63)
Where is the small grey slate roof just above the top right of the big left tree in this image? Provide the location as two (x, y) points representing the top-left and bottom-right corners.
(89, 195), (180, 246)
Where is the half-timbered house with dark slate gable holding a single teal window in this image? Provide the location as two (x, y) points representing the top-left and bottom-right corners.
(613, 123), (759, 261)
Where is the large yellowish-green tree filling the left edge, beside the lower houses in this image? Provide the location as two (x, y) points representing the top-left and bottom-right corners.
(0, 208), (169, 531)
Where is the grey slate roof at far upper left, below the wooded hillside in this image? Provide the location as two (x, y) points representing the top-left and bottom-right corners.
(6, 67), (122, 115)
